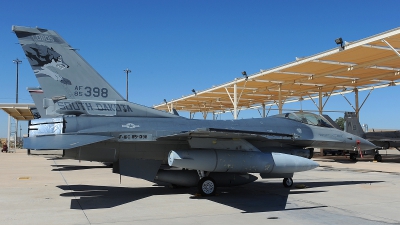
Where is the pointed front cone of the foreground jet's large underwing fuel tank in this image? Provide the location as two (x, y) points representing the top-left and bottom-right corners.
(271, 152), (319, 173)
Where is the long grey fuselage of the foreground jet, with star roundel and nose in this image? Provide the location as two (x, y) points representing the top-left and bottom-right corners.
(64, 116), (375, 151)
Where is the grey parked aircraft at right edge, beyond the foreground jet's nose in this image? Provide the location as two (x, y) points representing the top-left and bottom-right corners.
(344, 112), (400, 162)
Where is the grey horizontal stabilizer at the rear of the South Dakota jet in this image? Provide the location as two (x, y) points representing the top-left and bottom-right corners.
(24, 134), (114, 150)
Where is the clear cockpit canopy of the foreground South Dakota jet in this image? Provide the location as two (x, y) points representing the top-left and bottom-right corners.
(273, 112), (333, 128)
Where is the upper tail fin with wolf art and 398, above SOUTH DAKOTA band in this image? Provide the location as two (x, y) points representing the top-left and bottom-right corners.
(12, 26), (124, 101)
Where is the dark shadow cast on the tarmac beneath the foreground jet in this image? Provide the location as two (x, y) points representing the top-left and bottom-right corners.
(57, 181), (383, 213)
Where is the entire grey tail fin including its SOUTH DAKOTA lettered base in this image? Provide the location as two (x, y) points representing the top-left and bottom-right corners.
(12, 26), (178, 117)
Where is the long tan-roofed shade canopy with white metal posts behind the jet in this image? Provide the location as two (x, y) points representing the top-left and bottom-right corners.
(154, 27), (400, 119)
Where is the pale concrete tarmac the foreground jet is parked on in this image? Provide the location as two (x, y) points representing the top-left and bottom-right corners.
(0, 150), (400, 225)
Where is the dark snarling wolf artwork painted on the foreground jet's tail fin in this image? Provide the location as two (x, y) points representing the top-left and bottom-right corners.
(22, 44), (71, 85)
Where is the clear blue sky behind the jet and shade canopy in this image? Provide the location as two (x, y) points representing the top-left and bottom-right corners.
(0, 0), (400, 137)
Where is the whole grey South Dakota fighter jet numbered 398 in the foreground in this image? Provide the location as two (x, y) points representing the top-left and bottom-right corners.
(12, 26), (375, 196)
